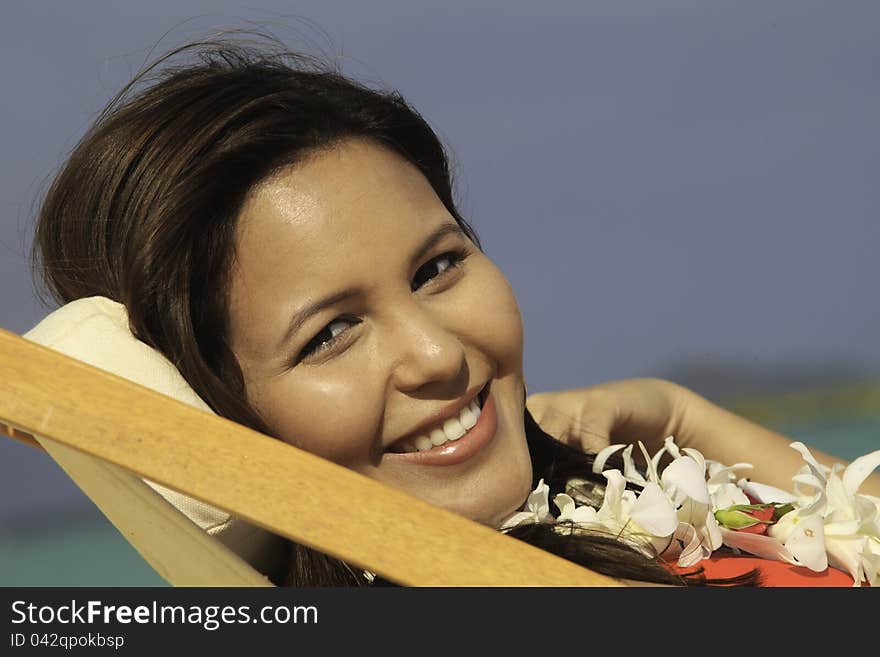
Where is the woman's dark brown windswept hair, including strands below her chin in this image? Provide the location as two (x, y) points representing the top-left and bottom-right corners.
(34, 40), (736, 586)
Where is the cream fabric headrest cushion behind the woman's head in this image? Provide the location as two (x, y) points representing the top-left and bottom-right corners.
(23, 296), (283, 574)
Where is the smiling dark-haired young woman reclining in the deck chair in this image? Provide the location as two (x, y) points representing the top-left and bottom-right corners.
(35, 38), (880, 586)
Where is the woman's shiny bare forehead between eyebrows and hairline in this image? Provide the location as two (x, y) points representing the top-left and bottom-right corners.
(236, 140), (449, 261)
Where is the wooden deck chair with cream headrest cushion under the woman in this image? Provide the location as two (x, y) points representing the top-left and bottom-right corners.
(0, 297), (619, 586)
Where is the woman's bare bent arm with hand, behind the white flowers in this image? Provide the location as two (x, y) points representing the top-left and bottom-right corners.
(526, 379), (880, 496)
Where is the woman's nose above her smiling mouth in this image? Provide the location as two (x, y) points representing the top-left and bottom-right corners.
(389, 310), (468, 392)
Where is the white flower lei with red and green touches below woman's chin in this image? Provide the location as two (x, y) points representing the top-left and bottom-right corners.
(501, 436), (880, 586)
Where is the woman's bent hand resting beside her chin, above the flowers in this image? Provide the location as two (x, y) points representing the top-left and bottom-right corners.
(526, 379), (693, 453)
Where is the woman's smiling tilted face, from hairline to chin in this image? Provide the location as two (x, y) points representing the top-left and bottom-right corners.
(230, 140), (531, 525)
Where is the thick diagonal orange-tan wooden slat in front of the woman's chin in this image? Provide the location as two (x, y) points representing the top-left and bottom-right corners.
(0, 330), (618, 586)
